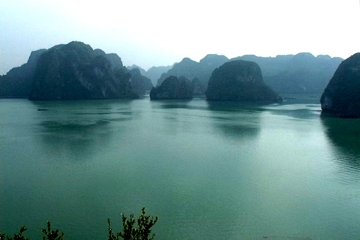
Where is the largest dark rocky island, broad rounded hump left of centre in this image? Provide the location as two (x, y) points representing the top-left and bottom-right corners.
(29, 42), (137, 100)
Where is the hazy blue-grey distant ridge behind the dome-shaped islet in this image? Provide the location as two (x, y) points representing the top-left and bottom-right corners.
(157, 52), (342, 95)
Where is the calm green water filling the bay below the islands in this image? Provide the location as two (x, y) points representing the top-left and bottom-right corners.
(0, 99), (360, 240)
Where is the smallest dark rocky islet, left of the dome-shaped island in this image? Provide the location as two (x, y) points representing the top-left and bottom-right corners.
(150, 76), (193, 100)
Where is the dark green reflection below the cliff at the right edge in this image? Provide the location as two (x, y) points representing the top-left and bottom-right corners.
(321, 117), (360, 171)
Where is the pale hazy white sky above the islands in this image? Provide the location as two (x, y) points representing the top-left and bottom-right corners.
(0, 0), (360, 74)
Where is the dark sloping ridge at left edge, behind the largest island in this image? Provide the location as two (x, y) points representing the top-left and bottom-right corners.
(0, 49), (46, 98)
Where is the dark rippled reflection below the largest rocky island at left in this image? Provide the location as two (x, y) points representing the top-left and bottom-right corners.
(30, 101), (133, 161)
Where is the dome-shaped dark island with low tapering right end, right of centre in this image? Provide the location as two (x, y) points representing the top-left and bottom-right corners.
(206, 60), (281, 101)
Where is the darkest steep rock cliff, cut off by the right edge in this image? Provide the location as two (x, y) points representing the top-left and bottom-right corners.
(321, 53), (360, 117)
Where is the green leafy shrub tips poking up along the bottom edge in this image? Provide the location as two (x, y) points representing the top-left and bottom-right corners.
(0, 208), (158, 240)
